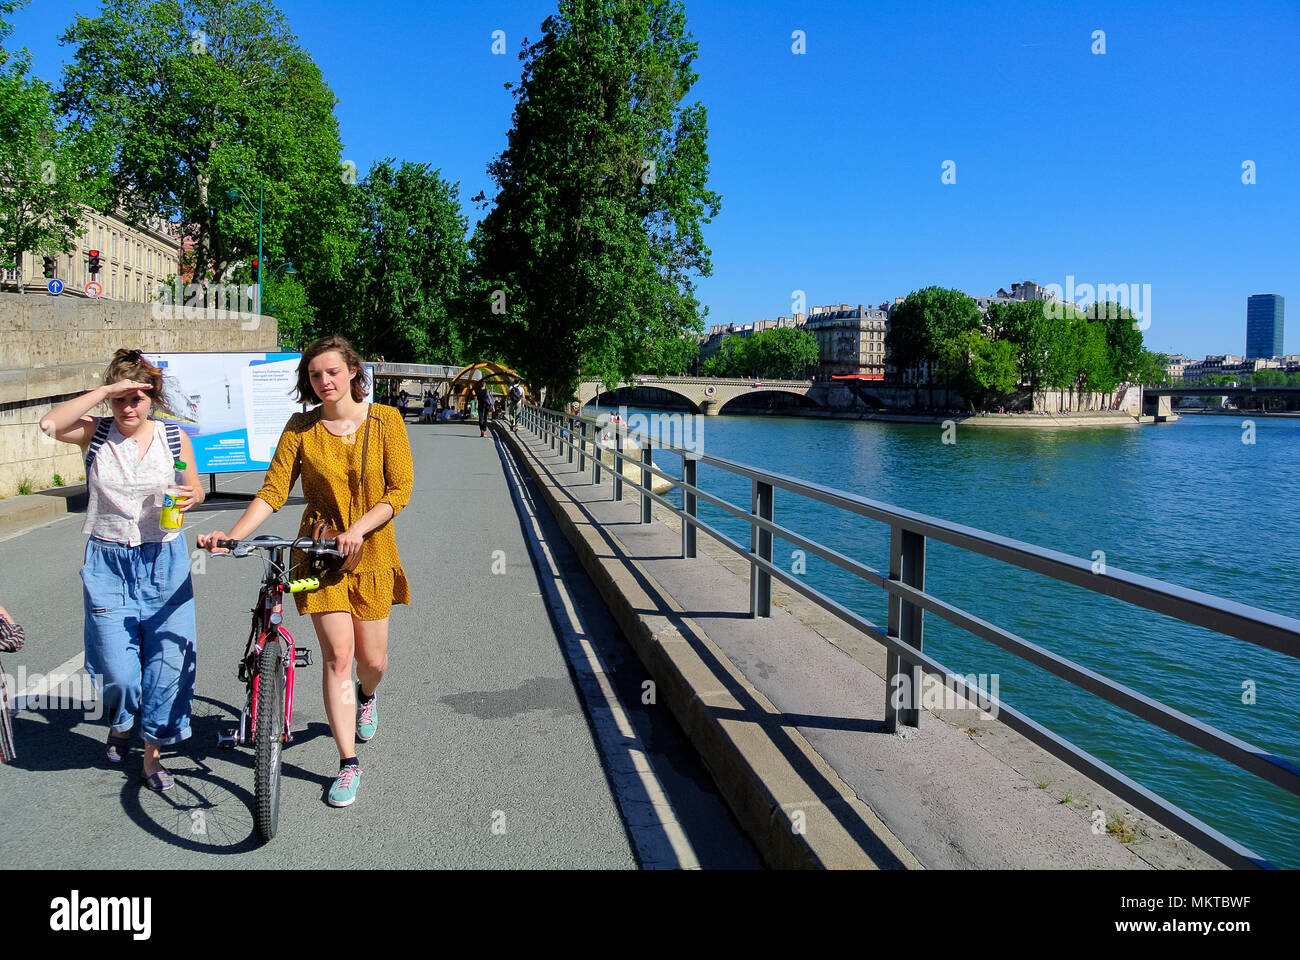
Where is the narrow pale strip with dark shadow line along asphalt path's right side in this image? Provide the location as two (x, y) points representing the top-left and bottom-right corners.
(498, 431), (699, 870)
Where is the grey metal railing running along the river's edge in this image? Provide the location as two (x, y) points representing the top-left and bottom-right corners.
(521, 405), (1300, 866)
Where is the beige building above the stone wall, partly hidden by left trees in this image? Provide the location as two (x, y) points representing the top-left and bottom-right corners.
(0, 207), (181, 303)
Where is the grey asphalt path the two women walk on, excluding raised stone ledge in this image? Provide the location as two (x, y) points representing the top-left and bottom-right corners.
(0, 423), (759, 869)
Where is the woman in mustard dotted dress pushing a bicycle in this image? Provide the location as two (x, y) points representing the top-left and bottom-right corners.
(198, 337), (415, 807)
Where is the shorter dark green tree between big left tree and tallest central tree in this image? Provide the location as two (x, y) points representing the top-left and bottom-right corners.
(351, 159), (468, 364)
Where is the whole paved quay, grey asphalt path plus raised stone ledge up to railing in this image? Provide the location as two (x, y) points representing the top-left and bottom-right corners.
(0, 423), (1218, 869)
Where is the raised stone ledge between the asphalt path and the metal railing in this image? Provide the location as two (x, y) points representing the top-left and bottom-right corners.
(491, 418), (1222, 869)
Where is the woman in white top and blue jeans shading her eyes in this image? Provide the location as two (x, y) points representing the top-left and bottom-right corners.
(40, 350), (204, 792)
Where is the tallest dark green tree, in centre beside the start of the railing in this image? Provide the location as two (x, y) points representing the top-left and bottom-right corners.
(471, 0), (719, 402)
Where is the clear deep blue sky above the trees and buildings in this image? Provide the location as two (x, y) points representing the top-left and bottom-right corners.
(10, 0), (1300, 356)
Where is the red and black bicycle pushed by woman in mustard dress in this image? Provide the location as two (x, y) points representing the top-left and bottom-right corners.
(216, 536), (343, 842)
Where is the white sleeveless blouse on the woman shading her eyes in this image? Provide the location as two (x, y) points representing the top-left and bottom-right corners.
(82, 420), (181, 546)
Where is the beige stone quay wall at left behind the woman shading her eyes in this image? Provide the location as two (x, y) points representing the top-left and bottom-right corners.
(0, 293), (277, 497)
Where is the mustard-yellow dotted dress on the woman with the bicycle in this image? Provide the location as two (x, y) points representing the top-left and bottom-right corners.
(257, 403), (415, 620)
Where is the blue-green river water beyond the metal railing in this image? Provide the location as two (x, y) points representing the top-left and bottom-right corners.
(595, 407), (1300, 868)
